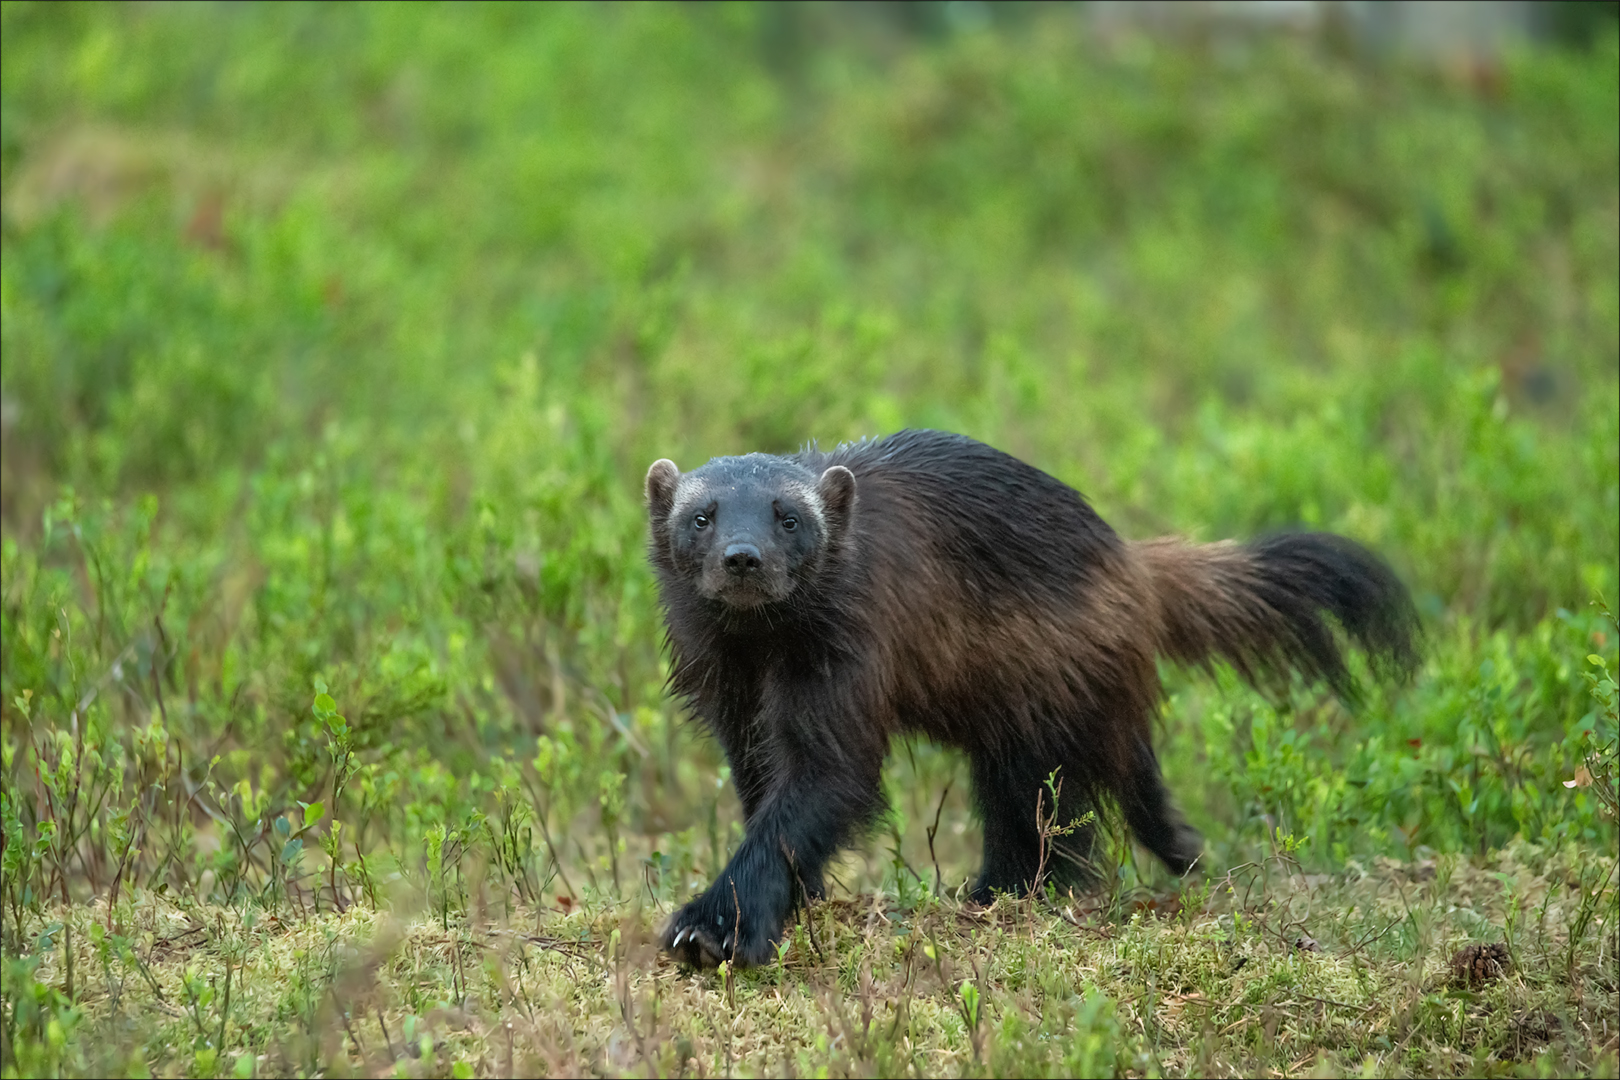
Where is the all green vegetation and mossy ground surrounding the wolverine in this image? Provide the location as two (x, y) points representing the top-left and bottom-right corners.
(0, 3), (1620, 1075)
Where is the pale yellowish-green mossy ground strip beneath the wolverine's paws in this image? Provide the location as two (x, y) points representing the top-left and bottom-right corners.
(3, 845), (1617, 1077)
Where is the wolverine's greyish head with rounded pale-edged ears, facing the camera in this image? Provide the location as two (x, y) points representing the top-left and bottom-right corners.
(646, 453), (855, 609)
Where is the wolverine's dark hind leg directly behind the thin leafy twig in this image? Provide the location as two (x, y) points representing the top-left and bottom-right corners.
(972, 750), (1095, 904)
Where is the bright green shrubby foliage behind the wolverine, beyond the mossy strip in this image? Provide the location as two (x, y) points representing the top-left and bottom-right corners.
(0, 3), (1620, 947)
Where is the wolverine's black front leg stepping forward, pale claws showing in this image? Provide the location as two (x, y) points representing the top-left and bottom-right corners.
(663, 683), (885, 967)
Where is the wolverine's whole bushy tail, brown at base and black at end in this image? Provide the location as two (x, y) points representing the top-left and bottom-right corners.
(1132, 533), (1419, 701)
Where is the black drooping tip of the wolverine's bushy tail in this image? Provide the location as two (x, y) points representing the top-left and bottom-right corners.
(1249, 533), (1422, 701)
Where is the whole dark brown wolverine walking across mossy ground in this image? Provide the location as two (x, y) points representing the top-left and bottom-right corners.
(646, 431), (1418, 967)
